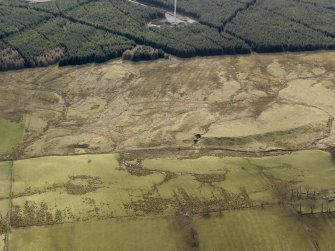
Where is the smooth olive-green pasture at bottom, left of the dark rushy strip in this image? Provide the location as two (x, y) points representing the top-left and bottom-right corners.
(9, 218), (187, 251)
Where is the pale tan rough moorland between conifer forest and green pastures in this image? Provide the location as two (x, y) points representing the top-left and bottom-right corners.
(0, 52), (335, 157)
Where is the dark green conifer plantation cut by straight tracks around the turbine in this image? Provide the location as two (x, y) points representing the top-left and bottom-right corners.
(0, 0), (335, 70)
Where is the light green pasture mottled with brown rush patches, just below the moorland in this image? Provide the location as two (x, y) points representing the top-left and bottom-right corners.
(4, 151), (335, 231)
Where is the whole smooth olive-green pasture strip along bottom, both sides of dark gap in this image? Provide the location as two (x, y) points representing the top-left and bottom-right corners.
(9, 207), (335, 251)
